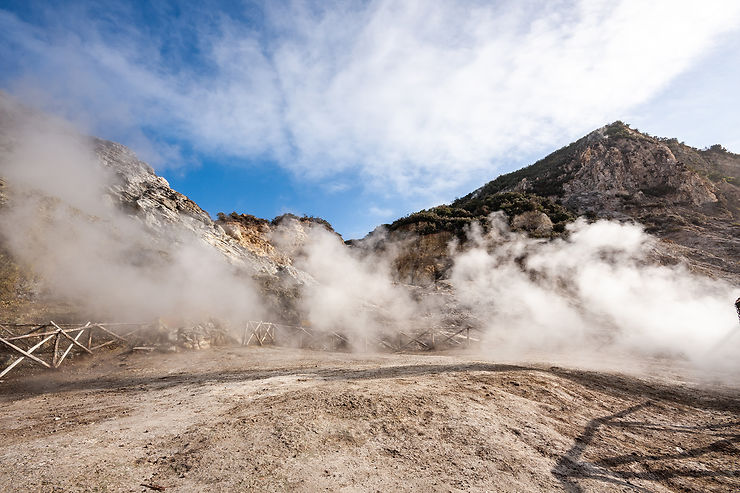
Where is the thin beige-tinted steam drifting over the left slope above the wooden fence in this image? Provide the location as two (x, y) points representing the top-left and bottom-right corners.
(0, 101), (260, 322)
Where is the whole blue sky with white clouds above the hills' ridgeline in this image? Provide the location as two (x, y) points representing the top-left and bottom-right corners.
(0, 0), (740, 238)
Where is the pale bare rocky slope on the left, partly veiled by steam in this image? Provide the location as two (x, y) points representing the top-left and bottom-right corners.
(0, 93), (318, 321)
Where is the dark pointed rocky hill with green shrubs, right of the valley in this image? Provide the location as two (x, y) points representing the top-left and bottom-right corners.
(376, 122), (740, 283)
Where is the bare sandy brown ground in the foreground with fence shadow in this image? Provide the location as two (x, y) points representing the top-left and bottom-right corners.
(0, 348), (740, 492)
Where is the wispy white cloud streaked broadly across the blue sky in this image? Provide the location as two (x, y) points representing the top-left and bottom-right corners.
(0, 0), (740, 198)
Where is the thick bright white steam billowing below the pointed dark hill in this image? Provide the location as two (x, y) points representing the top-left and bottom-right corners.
(451, 214), (740, 370)
